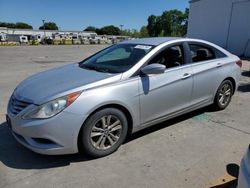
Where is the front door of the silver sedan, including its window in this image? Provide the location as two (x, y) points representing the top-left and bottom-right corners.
(139, 44), (193, 126)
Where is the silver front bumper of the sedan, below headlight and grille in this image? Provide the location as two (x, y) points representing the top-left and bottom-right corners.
(8, 105), (83, 155)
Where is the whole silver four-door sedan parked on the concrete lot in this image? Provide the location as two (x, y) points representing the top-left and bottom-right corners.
(6, 38), (242, 157)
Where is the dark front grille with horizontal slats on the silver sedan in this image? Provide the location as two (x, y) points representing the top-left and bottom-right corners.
(9, 95), (31, 115)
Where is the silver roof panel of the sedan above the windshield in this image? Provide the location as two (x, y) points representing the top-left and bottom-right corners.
(122, 37), (182, 46)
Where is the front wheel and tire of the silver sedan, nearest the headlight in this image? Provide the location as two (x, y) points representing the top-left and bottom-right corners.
(79, 108), (128, 158)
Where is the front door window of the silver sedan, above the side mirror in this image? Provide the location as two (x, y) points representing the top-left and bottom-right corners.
(149, 45), (184, 68)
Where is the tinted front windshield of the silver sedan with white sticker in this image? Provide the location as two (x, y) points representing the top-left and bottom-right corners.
(79, 44), (153, 73)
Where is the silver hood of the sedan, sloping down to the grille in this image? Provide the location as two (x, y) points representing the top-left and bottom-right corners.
(14, 64), (121, 105)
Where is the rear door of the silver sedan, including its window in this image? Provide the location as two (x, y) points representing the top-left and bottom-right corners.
(188, 42), (226, 106)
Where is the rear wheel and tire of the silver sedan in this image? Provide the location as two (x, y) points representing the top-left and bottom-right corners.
(214, 80), (233, 110)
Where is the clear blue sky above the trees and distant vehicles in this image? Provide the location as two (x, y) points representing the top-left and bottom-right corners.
(0, 0), (189, 30)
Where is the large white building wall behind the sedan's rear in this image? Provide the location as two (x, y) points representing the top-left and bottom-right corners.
(187, 0), (250, 57)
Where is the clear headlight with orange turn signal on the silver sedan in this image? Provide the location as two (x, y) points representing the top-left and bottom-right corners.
(22, 92), (81, 119)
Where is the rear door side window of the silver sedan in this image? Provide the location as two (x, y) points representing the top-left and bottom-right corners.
(189, 44), (216, 63)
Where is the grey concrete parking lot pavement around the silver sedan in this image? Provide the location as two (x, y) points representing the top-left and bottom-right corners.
(0, 45), (250, 188)
